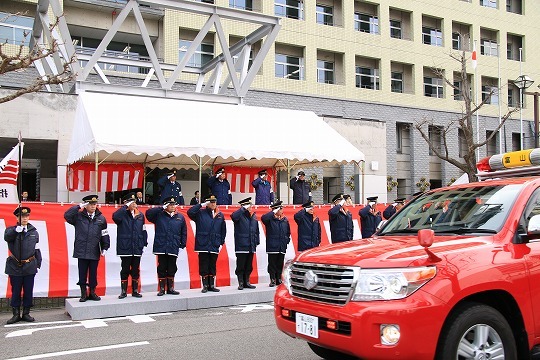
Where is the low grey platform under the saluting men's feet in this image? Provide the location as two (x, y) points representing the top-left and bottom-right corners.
(66, 284), (276, 320)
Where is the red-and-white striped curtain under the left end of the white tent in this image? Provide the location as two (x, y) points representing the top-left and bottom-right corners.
(67, 162), (144, 192)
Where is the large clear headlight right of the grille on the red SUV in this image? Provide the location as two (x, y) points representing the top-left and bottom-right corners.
(351, 266), (437, 301)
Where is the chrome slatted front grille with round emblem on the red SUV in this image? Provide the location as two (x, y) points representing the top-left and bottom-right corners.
(291, 263), (355, 305)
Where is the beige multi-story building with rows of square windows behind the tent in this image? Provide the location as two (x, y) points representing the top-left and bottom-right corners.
(0, 0), (540, 203)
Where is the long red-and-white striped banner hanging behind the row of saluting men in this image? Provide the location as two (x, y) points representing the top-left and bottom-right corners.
(0, 202), (384, 298)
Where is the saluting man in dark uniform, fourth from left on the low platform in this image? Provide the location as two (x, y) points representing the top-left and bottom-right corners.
(188, 195), (227, 293)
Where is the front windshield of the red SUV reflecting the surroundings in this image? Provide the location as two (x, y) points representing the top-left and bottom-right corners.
(379, 184), (523, 235)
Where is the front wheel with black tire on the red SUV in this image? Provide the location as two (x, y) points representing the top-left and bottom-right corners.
(436, 303), (517, 360)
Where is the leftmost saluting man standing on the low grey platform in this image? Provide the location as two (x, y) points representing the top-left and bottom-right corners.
(64, 195), (111, 302)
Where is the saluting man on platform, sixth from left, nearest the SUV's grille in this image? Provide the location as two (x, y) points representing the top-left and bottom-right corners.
(261, 200), (291, 287)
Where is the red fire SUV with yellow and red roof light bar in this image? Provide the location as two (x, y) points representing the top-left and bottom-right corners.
(274, 149), (540, 360)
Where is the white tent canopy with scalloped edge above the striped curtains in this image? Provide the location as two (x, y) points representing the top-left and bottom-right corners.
(68, 92), (364, 169)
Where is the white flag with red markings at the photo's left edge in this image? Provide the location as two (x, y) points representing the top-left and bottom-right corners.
(0, 142), (24, 204)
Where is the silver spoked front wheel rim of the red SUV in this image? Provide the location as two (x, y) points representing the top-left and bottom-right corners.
(456, 324), (504, 360)
